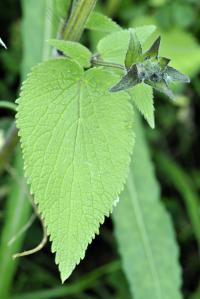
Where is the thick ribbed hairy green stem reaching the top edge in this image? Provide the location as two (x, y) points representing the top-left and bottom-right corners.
(63, 0), (96, 41)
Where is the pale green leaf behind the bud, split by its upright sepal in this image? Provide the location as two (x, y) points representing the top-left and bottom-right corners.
(97, 26), (155, 64)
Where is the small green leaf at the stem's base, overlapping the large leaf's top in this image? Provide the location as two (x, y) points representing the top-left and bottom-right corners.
(48, 39), (92, 67)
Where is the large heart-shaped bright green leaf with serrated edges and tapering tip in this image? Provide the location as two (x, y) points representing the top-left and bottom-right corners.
(17, 58), (134, 281)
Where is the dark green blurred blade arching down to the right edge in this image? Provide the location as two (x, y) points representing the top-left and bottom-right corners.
(156, 153), (200, 250)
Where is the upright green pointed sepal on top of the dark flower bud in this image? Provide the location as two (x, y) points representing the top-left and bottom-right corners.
(125, 29), (142, 69)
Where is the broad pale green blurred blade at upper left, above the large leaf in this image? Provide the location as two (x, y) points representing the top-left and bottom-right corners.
(21, 0), (58, 79)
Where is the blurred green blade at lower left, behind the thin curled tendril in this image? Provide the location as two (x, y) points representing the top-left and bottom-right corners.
(0, 147), (30, 298)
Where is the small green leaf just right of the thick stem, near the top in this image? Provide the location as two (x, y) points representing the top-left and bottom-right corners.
(85, 12), (121, 33)
